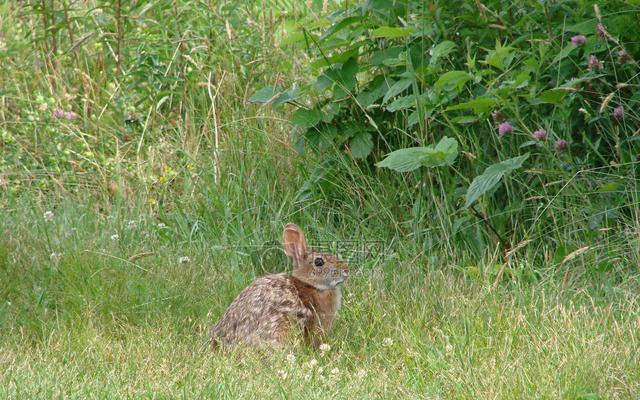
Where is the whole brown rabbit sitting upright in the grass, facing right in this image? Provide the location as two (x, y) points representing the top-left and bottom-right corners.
(211, 224), (349, 348)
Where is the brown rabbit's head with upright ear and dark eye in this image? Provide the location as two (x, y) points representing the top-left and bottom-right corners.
(282, 224), (349, 290)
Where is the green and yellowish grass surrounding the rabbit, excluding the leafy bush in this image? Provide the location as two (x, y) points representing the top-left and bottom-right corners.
(0, 1), (640, 400)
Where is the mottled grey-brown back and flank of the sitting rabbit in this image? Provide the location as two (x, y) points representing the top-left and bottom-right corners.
(211, 274), (310, 346)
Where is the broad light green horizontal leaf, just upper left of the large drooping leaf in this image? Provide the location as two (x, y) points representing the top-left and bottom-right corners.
(376, 136), (458, 172)
